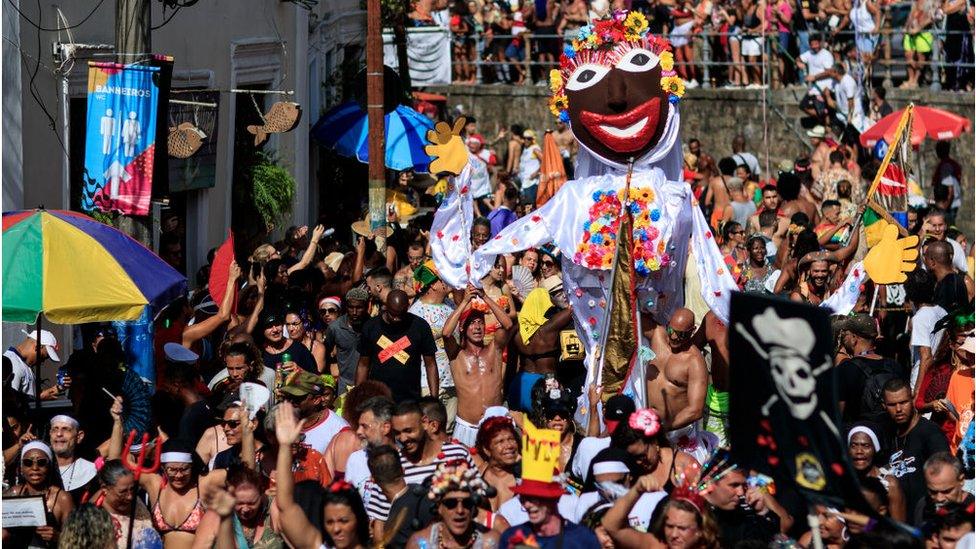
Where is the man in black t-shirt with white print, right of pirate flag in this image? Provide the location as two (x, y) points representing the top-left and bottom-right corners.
(884, 378), (949, 510)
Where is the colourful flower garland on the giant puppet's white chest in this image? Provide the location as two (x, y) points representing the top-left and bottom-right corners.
(573, 187), (671, 277)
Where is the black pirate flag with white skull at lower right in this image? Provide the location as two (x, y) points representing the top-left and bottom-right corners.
(729, 292), (875, 516)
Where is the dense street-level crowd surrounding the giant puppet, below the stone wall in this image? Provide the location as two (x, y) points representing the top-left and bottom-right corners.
(3, 112), (976, 549)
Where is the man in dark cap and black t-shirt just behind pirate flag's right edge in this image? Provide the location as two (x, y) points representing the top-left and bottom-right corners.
(837, 313), (908, 423)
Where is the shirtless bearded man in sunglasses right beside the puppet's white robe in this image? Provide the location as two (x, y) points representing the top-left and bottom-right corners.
(644, 307), (708, 461)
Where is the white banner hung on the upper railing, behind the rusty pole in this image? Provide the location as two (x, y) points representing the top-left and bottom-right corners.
(383, 27), (451, 86)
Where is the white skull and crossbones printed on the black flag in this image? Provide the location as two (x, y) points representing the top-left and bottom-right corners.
(735, 307), (837, 432)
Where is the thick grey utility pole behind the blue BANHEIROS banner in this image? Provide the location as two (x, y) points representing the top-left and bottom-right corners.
(115, 0), (152, 244)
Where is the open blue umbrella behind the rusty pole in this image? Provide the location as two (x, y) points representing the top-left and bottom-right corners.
(312, 101), (434, 173)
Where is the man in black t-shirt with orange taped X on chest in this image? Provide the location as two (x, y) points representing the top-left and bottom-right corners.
(356, 290), (438, 403)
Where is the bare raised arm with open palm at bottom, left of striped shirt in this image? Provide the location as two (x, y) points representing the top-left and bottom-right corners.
(275, 401), (322, 547)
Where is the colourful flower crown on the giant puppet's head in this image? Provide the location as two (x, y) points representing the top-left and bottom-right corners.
(549, 10), (685, 123)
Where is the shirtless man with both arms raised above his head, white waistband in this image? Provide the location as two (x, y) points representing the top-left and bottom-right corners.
(441, 286), (514, 447)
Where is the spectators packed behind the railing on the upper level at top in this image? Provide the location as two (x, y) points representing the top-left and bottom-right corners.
(409, 0), (974, 91)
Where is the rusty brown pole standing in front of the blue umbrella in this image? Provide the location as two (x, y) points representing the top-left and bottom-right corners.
(366, 0), (386, 242)
